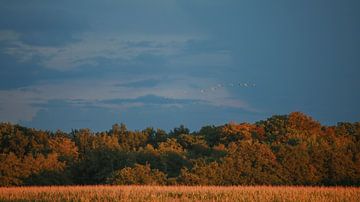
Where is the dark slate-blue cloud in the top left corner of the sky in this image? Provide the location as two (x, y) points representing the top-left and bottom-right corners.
(0, 1), (90, 46)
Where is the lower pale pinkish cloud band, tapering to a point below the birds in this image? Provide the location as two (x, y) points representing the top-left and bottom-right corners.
(0, 77), (254, 121)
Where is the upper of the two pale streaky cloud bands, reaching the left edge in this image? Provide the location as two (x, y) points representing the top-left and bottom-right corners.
(0, 28), (232, 73)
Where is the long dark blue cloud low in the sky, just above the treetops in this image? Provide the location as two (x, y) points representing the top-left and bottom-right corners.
(20, 96), (259, 131)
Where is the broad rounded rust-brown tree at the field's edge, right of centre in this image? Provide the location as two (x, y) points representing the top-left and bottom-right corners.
(220, 140), (286, 185)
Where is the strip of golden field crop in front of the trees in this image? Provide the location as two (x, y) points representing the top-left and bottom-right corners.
(0, 186), (360, 202)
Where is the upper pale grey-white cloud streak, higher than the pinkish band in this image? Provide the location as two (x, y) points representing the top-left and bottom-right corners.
(0, 31), (235, 71)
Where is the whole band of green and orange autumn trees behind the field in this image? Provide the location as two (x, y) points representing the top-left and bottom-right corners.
(0, 112), (360, 186)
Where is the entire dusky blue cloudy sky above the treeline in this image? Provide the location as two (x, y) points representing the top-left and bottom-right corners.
(0, 0), (360, 131)
